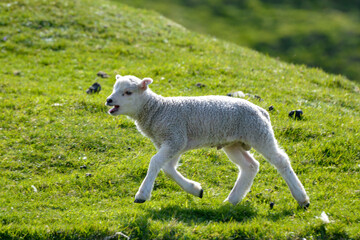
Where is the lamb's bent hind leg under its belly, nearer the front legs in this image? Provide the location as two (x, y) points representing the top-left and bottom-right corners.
(223, 144), (260, 205)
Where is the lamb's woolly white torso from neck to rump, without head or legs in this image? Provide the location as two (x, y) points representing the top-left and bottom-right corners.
(134, 89), (273, 154)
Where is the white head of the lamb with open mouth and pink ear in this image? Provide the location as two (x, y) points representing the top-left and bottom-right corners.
(105, 75), (152, 116)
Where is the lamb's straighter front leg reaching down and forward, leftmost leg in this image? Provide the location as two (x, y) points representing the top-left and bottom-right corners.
(135, 145), (174, 203)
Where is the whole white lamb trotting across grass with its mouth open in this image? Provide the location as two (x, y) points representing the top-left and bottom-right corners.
(105, 75), (310, 208)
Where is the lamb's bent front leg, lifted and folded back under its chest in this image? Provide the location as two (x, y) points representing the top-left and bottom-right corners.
(163, 158), (203, 198)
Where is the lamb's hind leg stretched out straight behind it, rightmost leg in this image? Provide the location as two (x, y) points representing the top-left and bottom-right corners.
(256, 141), (310, 208)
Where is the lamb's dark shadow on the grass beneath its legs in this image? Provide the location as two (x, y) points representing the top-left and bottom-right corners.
(148, 204), (257, 224)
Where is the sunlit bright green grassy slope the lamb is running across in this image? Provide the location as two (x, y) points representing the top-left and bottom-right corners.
(0, 0), (360, 239)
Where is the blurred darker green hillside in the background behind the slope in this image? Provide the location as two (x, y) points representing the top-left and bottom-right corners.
(116, 0), (360, 82)
